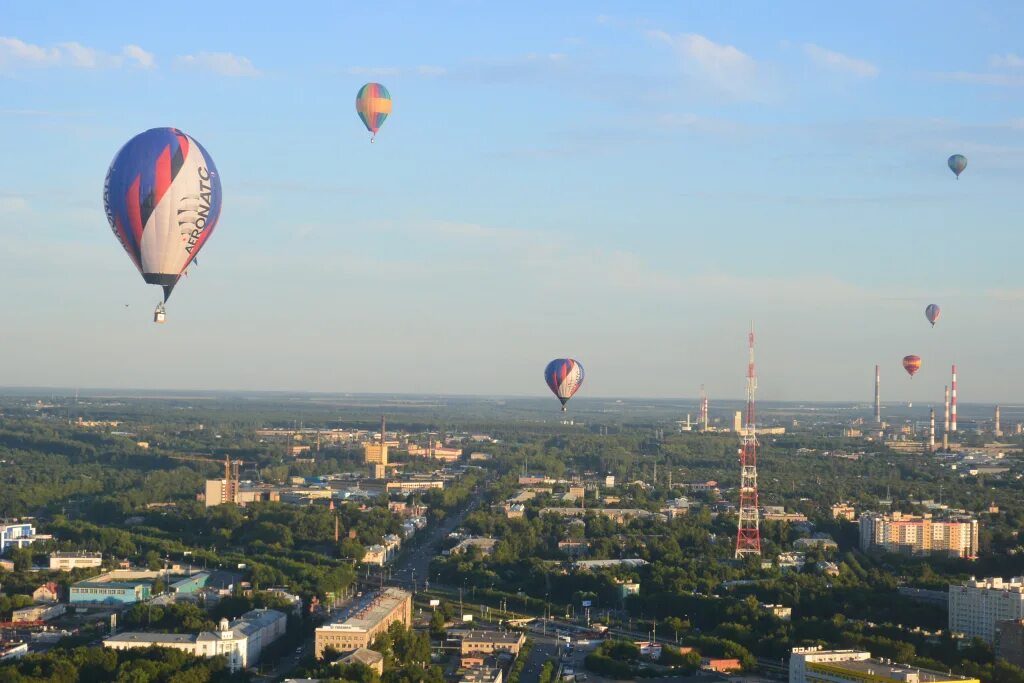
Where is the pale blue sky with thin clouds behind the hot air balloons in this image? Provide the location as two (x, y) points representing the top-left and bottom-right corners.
(0, 1), (1024, 401)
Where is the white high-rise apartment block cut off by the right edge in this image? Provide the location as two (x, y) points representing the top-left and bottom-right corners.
(949, 577), (1024, 643)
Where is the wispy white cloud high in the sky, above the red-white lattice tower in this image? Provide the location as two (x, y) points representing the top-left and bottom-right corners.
(647, 30), (763, 99)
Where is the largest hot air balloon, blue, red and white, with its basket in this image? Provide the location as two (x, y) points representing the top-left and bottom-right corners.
(103, 128), (220, 323)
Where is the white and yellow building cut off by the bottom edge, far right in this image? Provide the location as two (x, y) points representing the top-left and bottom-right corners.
(790, 647), (980, 683)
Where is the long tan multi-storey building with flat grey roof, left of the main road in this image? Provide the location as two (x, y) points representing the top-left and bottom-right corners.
(314, 588), (413, 659)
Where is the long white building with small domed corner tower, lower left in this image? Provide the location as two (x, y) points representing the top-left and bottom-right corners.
(103, 609), (288, 671)
